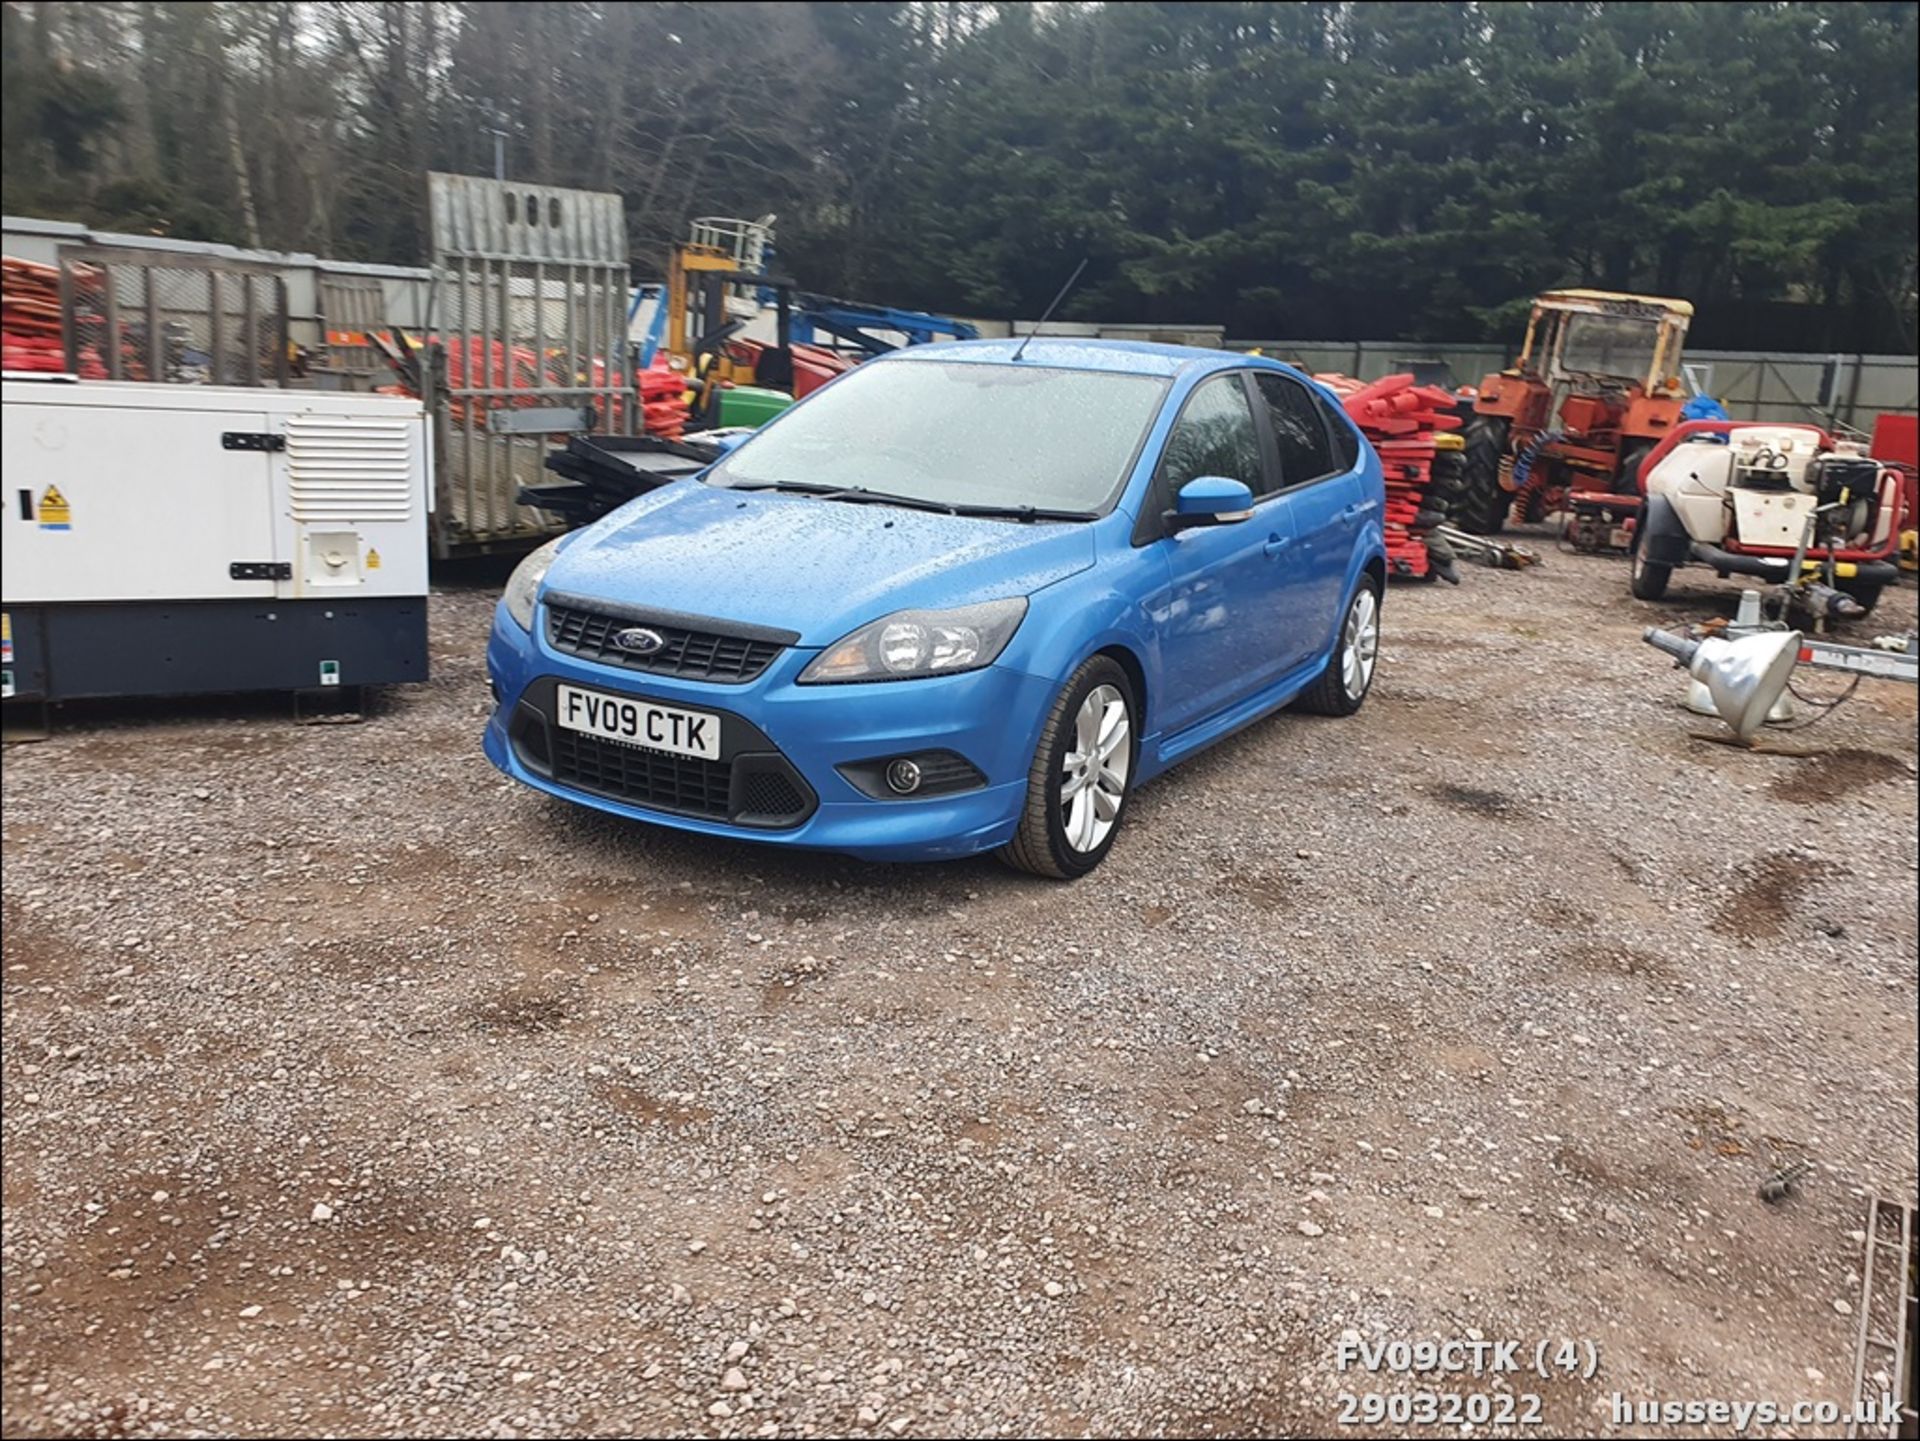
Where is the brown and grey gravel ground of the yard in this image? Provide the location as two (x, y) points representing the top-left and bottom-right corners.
(0, 555), (1916, 1435)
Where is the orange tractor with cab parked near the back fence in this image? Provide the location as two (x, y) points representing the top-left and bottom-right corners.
(1455, 290), (1693, 549)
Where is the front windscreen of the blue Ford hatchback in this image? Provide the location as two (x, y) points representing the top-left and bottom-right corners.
(708, 361), (1165, 510)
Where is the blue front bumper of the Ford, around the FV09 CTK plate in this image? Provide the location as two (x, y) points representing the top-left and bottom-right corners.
(484, 606), (1054, 860)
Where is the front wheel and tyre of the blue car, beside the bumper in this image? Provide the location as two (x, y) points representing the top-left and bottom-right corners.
(998, 656), (1140, 881)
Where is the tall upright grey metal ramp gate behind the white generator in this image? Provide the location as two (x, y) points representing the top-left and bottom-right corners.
(422, 175), (639, 556)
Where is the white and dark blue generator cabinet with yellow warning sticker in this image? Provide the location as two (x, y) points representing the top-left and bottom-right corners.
(0, 374), (432, 702)
